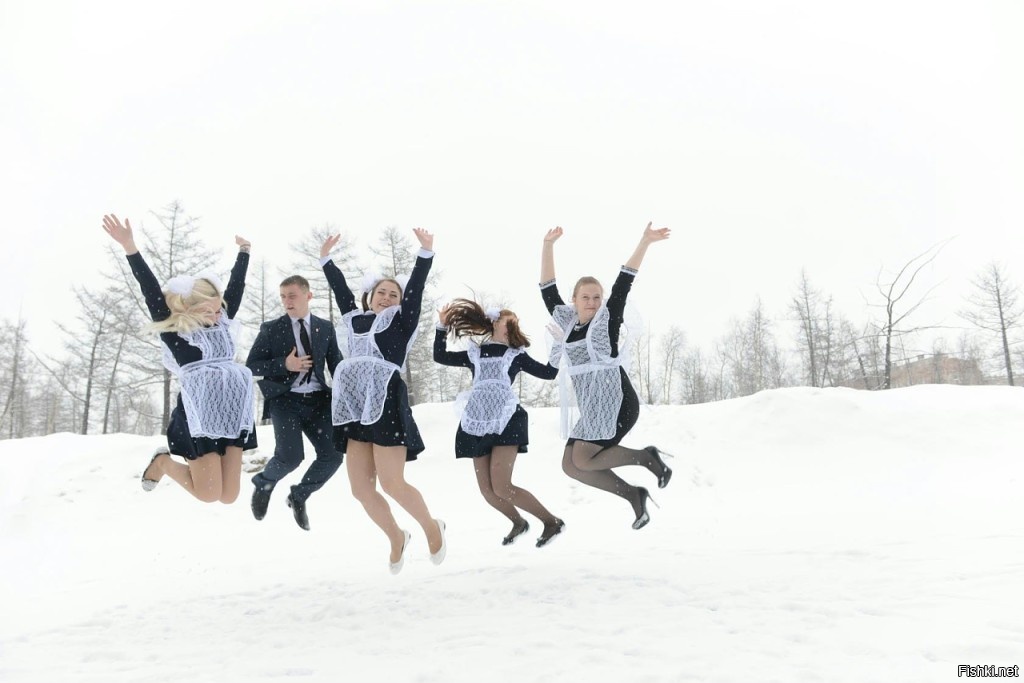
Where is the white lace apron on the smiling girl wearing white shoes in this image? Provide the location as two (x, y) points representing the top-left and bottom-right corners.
(331, 306), (416, 425)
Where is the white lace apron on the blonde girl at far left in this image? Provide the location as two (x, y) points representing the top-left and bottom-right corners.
(164, 318), (255, 438)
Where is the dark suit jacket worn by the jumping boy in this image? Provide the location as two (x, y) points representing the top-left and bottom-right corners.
(246, 315), (341, 398)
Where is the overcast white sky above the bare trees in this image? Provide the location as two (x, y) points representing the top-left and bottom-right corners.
(0, 0), (1024, 358)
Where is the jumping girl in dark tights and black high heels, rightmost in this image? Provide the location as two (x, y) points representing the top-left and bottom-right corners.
(541, 223), (672, 529)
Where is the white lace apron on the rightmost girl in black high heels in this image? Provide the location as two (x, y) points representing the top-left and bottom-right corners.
(551, 305), (623, 441)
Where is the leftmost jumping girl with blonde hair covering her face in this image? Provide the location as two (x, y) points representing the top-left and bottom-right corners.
(103, 215), (256, 503)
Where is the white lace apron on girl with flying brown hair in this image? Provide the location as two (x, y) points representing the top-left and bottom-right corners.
(455, 343), (522, 436)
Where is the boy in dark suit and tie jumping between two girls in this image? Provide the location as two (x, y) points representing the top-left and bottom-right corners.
(246, 275), (343, 530)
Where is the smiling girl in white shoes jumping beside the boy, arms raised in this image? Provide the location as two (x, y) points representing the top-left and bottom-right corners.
(321, 228), (446, 573)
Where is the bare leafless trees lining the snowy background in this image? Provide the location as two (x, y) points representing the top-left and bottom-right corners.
(0, 202), (1024, 438)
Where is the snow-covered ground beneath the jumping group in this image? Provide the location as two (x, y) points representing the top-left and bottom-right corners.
(0, 386), (1024, 683)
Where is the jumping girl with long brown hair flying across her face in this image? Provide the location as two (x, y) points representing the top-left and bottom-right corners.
(434, 299), (565, 548)
